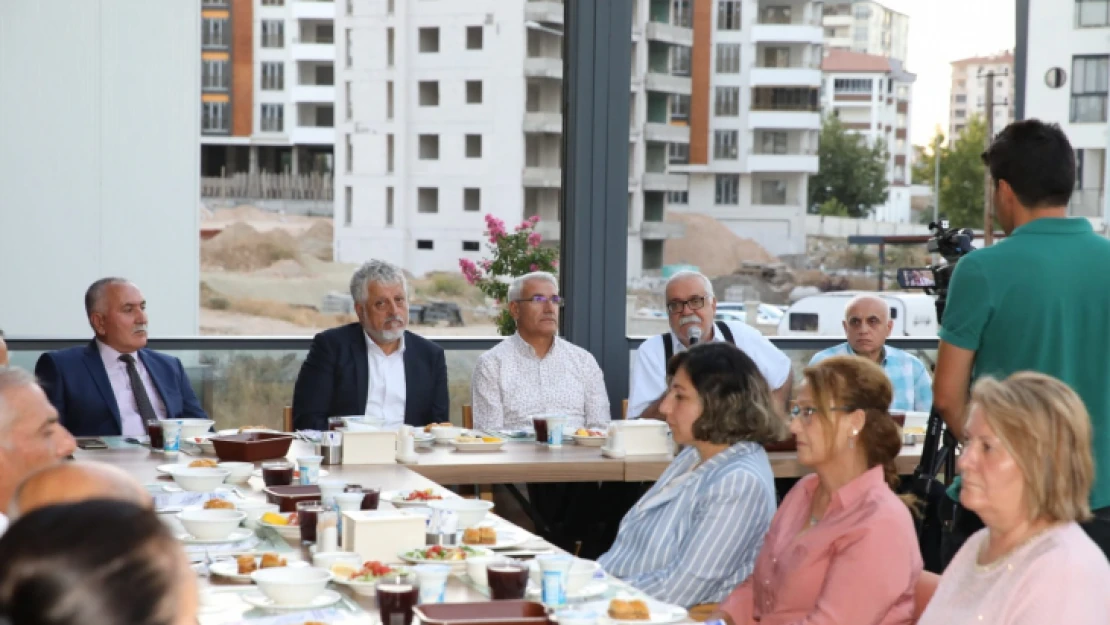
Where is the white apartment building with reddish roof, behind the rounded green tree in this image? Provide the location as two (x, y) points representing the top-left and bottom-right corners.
(821, 50), (917, 223)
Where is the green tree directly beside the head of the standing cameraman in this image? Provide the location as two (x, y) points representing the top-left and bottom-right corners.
(914, 115), (987, 229)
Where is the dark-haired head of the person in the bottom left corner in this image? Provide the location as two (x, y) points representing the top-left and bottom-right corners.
(0, 500), (196, 625)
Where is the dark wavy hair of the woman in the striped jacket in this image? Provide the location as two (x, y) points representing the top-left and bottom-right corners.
(667, 343), (786, 445)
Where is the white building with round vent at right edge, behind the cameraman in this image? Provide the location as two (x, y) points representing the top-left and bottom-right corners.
(1016, 0), (1110, 220)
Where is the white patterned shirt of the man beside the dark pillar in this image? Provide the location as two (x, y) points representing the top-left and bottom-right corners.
(471, 334), (609, 430)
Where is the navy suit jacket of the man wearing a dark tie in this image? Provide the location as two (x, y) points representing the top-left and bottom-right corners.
(34, 341), (208, 436)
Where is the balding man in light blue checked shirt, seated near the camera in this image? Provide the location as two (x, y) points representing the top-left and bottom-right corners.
(809, 294), (932, 412)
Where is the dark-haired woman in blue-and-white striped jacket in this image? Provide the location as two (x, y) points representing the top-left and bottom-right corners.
(598, 343), (786, 606)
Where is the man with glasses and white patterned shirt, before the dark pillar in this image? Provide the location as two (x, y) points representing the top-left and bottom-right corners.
(471, 272), (609, 431)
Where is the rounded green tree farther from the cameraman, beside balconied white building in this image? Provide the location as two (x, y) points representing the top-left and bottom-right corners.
(809, 115), (888, 218)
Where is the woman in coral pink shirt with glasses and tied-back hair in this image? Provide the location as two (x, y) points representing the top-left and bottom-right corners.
(717, 356), (921, 625)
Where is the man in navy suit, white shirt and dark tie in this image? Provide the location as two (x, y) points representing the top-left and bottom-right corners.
(34, 278), (208, 436)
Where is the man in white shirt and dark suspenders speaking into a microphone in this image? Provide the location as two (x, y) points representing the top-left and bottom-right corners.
(627, 271), (794, 419)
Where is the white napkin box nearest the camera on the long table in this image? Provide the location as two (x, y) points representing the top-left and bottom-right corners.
(343, 510), (427, 563)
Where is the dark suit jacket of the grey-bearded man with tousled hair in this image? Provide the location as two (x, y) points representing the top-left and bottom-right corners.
(293, 323), (451, 430)
